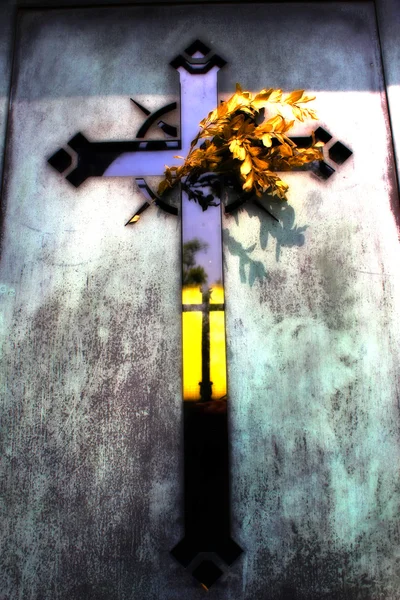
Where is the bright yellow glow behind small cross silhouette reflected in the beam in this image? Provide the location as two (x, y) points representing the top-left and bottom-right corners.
(182, 285), (226, 401)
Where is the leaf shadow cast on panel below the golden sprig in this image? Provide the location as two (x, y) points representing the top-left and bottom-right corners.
(223, 196), (308, 287)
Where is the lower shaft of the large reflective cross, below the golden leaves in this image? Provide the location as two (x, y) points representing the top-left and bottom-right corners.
(178, 191), (242, 588)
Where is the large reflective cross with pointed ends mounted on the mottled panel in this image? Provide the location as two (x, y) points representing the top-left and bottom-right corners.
(48, 40), (351, 589)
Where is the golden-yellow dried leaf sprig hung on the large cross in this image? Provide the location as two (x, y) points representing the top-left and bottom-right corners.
(158, 84), (323, 210)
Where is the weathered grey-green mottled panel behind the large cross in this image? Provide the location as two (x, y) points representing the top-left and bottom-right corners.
(0, 3), (400, 600)
